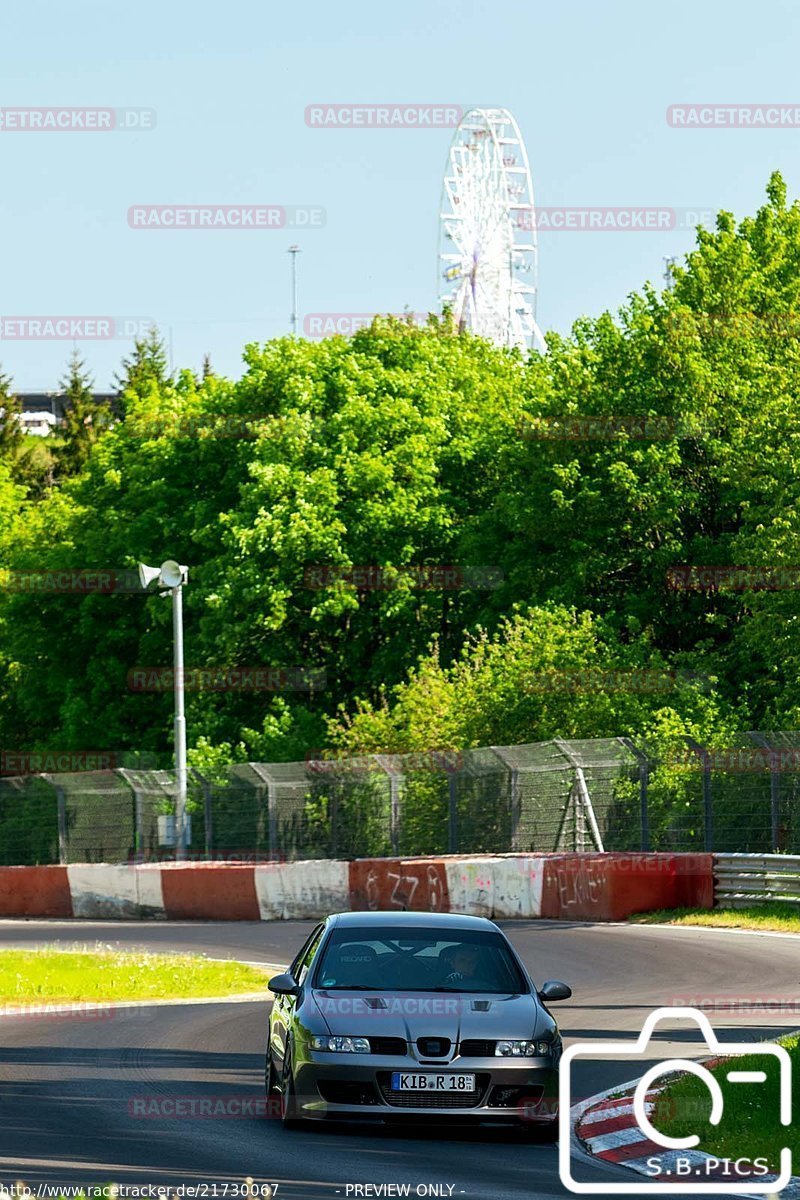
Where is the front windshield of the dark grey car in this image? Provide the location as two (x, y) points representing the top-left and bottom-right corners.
(314, 925), (529, 995)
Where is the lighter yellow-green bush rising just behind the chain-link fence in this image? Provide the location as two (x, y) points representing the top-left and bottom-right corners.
(331, 604), (718, 755)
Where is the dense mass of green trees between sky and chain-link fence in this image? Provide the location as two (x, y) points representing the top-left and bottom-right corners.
(0, 176), (800, 762)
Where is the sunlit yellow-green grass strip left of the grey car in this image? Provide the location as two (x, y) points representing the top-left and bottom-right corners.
(0, 947), (275, 1004)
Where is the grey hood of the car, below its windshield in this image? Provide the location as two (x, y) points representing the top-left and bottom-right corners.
(309, 989), (555, 1042)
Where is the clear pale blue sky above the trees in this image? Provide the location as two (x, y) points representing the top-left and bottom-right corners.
(0, 0), (800, 390)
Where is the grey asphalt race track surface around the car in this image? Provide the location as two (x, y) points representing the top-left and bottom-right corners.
(0, 920), (800, 1200)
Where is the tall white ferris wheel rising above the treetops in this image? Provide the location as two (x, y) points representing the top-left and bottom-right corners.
(439, 108), (547, 353)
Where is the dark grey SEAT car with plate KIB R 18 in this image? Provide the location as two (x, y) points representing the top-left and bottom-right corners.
(265, 912), (571, 1138)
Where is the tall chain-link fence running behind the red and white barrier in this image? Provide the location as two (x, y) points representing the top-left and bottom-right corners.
(0, 731), (800, 865)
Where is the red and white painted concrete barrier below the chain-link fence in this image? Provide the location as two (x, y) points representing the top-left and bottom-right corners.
(0, 853), (714, 922)
